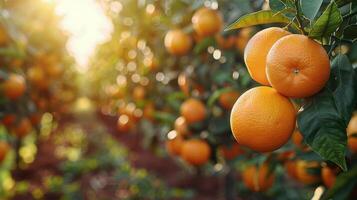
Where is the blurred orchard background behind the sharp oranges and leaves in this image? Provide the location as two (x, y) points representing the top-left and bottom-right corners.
(0, 0), (357, 200)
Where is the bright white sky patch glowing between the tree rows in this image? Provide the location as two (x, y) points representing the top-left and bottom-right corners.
(44, 0), (113, 71)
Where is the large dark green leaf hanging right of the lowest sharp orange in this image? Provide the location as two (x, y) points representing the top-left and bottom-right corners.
(298, 55), (356, 170)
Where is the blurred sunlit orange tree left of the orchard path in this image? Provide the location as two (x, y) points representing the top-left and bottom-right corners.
(0, 1), (75, 195)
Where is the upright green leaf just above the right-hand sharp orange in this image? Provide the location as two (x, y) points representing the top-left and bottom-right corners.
(309, 1), (342, 39)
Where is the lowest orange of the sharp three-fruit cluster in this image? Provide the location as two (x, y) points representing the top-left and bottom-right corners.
(230, 86), (296, 152)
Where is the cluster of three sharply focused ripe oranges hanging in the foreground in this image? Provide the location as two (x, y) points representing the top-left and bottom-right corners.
(231, 27), (330, 152)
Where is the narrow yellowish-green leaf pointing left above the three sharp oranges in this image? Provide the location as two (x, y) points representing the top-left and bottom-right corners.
(225, 10), (290, 31)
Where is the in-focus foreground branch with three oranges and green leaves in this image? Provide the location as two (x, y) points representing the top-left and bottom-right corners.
(227, 0), (357, 199)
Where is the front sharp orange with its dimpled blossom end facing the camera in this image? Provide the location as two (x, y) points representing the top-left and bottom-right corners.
(266, 34), (330, 98)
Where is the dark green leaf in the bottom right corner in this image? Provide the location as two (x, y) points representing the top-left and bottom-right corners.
(323, 167), (357, 199)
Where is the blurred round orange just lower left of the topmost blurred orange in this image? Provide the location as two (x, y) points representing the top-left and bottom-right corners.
(164, 29), (192, 56)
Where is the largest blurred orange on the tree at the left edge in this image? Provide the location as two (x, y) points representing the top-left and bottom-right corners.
(3, 74), (26, 100)
